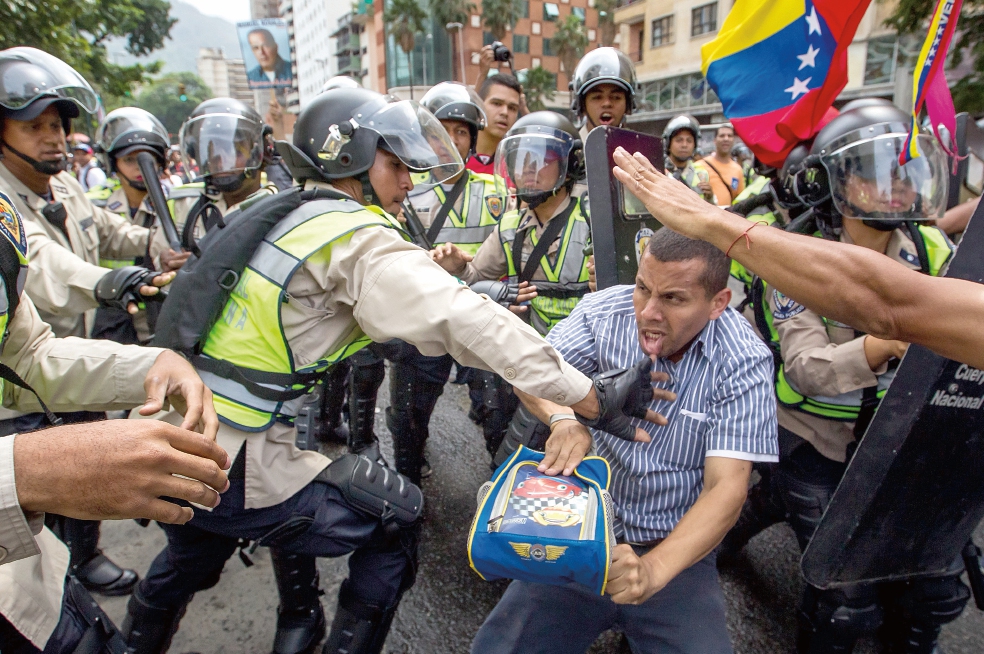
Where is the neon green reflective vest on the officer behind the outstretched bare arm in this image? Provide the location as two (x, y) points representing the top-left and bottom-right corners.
(768, 225), (953, 422)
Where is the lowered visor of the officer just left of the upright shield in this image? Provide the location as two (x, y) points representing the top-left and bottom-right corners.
(494, 129), (574, 197)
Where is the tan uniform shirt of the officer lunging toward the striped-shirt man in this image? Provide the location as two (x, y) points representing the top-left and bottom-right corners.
(164, 182), (591, 509)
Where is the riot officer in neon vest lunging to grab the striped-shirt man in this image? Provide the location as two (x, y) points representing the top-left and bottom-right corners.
(122, 89), (638, 654)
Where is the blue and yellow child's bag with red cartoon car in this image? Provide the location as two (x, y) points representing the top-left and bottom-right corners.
(468, 446), (615, 595)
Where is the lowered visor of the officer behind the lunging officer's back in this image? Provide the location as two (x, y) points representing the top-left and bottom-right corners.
(181, 114), (263, 177)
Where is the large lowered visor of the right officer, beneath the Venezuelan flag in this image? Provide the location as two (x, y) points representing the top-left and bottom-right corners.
(821, 133), (949, 221)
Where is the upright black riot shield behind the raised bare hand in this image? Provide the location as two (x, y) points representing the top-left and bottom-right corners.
(584, 126), (665, 289)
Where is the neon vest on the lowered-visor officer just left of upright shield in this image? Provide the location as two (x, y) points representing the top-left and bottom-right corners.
(499, 198), (591, 336)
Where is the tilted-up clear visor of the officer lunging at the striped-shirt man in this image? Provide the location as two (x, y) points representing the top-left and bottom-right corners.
(355, 100), (465, 184)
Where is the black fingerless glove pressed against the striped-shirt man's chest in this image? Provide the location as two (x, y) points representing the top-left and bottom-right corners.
(575, 357), (653, 441)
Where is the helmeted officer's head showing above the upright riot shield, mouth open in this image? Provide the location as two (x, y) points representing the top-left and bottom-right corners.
(569, 47), (638, 141)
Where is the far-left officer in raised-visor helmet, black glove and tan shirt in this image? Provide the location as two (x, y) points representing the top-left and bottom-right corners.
(0, 48), (170, 595)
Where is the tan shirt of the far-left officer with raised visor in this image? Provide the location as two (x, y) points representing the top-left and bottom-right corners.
(0, 163), (149, 337)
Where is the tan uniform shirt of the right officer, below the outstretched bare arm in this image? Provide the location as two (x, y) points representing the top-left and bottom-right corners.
(767, 230), (919, 461)
